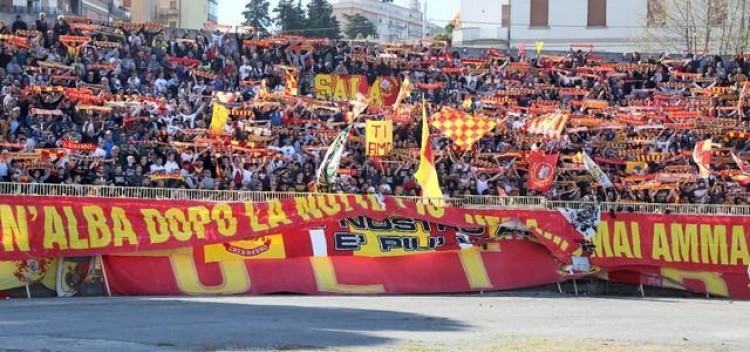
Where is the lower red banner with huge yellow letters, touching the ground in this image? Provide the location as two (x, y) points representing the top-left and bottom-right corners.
(104, 241), (563, 295)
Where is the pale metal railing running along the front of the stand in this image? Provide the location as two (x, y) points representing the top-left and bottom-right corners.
(0, 182), (750, 216)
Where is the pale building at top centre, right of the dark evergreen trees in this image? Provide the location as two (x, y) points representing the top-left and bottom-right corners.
(333, 0), (442, 41)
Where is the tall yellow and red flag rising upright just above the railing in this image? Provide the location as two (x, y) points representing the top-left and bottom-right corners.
(414, 97), (445, 206)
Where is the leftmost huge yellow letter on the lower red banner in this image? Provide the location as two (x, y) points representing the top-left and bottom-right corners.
(169, 255), (252, 295)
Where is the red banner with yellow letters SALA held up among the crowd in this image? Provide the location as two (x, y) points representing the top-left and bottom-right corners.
(314, 74), (399, 107)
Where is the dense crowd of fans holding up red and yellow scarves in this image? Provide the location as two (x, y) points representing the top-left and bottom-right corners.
(0, 14), (750, 204)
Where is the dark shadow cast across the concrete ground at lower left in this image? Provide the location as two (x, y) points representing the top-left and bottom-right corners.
(0, 296), (469, 351)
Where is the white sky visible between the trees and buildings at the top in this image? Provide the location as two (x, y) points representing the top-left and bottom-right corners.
(219, 0), (459, 27)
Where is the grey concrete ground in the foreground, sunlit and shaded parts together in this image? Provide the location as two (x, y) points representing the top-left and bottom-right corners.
(0, 295), (750, 352)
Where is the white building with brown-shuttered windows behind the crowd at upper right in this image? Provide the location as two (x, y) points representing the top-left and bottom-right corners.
(453, 0), (727, 52)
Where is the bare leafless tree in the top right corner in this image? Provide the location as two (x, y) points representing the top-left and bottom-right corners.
(637, 0), (750, 55)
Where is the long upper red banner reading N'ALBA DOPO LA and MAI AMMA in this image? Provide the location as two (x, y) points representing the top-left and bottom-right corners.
(0, 195), (750, 272)
